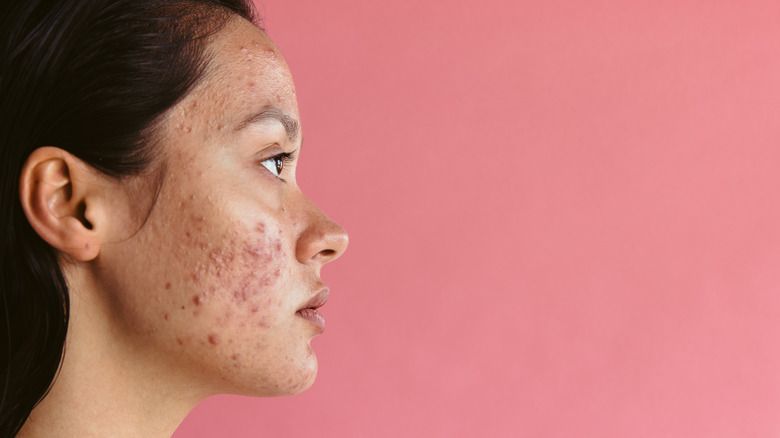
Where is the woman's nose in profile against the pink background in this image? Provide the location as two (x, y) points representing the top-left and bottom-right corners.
(295, 199), (349, 268)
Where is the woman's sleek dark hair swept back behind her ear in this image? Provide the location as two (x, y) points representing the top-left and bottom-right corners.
(0, 0), (255, 436)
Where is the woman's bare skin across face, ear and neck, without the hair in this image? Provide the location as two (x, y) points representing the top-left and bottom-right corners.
(20, 18), (347, 436)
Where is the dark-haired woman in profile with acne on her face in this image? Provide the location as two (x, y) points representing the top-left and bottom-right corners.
(0, 0), (347, 437)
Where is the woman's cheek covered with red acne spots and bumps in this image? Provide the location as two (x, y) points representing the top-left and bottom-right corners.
(161, 217), (294, 346)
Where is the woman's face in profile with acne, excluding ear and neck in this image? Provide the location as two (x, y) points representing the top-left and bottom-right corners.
(96, 19), (347, 395)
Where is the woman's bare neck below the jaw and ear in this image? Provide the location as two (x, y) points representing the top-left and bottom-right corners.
(18, 270), (205, 438)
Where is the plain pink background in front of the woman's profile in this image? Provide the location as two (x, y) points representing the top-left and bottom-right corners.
(176, 0), (780, 438)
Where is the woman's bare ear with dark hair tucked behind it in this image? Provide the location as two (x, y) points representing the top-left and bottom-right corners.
(19, 146), (106, 261)
